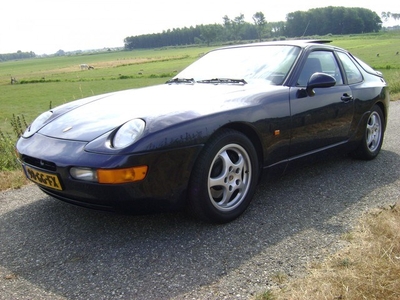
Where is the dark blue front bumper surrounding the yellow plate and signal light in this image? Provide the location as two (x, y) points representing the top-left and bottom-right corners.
(16, 134), (202, 212)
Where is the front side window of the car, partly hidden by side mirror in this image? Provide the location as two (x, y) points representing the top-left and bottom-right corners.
(297, 51), (343, 86)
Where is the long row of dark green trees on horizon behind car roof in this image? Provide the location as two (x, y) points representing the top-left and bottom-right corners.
(124, 6), (384, 50)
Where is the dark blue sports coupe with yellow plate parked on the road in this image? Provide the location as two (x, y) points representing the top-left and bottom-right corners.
(17, 41), (389, 223)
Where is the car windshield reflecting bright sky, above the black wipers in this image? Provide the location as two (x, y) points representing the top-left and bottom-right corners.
(175, 45), (300, 85)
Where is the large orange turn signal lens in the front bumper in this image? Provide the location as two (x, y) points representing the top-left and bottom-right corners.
(97, 166), (148, 184)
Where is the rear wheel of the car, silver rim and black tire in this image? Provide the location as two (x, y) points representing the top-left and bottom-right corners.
(352, 105), (385, 160)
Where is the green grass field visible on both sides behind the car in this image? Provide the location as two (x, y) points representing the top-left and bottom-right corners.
(0, 31), (400, 133)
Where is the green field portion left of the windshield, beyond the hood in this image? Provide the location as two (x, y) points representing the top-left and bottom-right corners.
(0, 47), (212, 132)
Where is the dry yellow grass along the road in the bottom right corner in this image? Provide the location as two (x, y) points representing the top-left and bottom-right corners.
(255, 199), (400, 300)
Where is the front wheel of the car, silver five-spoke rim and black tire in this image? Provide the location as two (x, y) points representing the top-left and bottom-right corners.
(188, 129), (260, 223)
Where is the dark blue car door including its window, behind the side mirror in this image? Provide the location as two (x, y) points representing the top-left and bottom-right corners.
(290, 50), (354, 157)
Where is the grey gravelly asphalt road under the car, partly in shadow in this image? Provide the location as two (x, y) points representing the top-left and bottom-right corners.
(0, 101), (400, 300)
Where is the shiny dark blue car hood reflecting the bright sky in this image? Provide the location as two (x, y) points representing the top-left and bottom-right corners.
(39, 84), (277, 142)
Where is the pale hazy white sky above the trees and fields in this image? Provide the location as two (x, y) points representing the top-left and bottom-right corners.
(0, 0), (400, 55)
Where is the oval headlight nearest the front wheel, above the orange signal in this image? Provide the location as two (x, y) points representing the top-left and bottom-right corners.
(112, 119), (146, 148)
